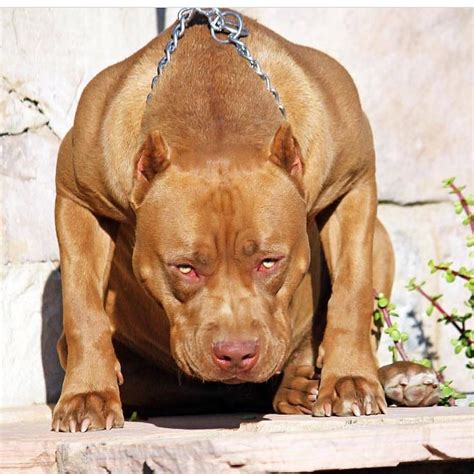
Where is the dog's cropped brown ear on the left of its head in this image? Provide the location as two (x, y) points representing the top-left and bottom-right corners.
(130, 130), (170, 209)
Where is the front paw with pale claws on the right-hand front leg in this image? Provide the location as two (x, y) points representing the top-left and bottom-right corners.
(313, 372), (387, 416)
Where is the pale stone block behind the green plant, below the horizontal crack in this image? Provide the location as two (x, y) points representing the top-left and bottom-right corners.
(378, 203), (472, 391)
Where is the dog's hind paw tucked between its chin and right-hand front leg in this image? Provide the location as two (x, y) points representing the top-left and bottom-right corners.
(273, 365), (319, 415)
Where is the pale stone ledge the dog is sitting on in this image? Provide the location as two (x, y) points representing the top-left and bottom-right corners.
(0, 407), (474, 474)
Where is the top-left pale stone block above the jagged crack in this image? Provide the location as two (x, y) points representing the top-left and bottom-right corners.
(0, 8), (156, 137)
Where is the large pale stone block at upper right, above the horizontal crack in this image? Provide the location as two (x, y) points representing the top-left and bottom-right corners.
(213, 8), (474, 203)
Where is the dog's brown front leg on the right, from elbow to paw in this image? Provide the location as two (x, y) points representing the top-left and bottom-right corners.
(313, 175), (386, 416)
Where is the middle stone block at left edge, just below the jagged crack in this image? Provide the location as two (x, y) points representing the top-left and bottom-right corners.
(0, 127), (59, 263)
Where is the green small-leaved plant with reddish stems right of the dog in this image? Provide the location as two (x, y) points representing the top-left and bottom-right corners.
(374, 178), (474, 406)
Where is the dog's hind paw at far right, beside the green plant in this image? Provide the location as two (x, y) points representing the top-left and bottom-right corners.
(379, 362), (440, 407)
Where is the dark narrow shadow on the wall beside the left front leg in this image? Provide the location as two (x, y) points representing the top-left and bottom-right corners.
(41, 269), (64, 403)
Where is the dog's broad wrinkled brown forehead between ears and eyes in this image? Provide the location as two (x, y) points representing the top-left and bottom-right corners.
(147, 168), (305, 253)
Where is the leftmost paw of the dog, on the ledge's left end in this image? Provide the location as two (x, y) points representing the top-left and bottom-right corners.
(52, 390), (124, 433)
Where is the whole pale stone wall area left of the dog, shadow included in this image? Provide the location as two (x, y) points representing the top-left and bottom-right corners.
(0, 8), (157, 406)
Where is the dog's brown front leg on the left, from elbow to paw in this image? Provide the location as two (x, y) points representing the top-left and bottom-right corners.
(52, 196), (124, 431)
